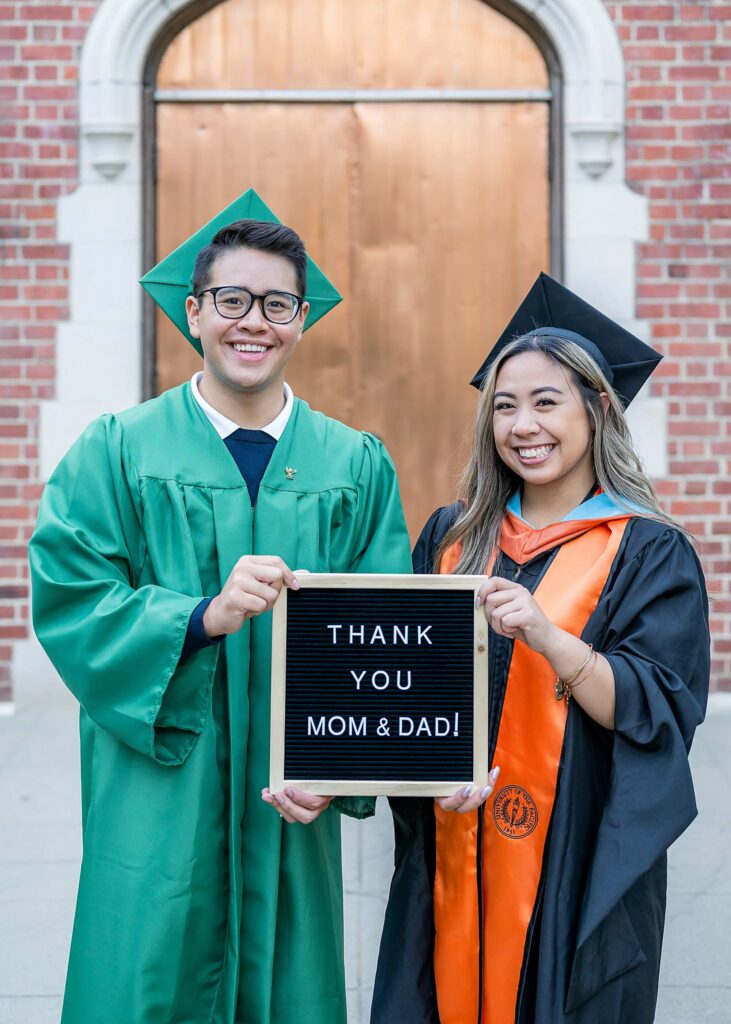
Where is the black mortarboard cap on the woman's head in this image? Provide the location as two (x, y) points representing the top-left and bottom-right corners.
(470, 273), (662, 409)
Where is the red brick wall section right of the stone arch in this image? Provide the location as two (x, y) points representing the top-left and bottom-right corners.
(606, 0), (731, 689)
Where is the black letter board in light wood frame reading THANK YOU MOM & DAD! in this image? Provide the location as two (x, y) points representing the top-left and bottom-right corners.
(269, 573), (487, 797)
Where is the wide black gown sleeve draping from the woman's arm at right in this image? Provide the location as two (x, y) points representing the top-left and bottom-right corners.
(567, 521), (711, 1009)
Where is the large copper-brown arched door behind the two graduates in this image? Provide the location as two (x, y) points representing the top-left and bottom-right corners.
(157, 0), (550, 537)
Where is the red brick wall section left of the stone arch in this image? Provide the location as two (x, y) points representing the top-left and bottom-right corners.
(0, 0), (97, 700)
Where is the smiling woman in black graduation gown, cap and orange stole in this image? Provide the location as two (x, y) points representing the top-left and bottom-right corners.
(371, 274), (710, 1024)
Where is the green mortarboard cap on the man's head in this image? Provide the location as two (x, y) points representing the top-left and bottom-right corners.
(140, 188), (342, 355)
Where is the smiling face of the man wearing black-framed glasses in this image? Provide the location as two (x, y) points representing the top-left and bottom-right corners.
(186, 247), (308, 400)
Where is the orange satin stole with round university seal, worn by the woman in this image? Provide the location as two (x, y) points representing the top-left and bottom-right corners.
(434, 513), (629, 1024)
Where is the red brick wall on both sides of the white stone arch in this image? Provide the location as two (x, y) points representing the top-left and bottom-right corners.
(0, 0), (731, 700)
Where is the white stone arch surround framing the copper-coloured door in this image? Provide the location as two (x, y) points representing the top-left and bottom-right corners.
(48, 0), (660, 477)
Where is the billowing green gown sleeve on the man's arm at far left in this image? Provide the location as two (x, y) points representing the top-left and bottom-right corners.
(30, 417), (218, 765)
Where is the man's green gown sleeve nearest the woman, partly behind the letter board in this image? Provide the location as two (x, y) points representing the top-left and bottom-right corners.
(333, 434), (412, 818)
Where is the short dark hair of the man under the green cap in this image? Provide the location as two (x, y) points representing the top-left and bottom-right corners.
(190, 220), (307, 298)
